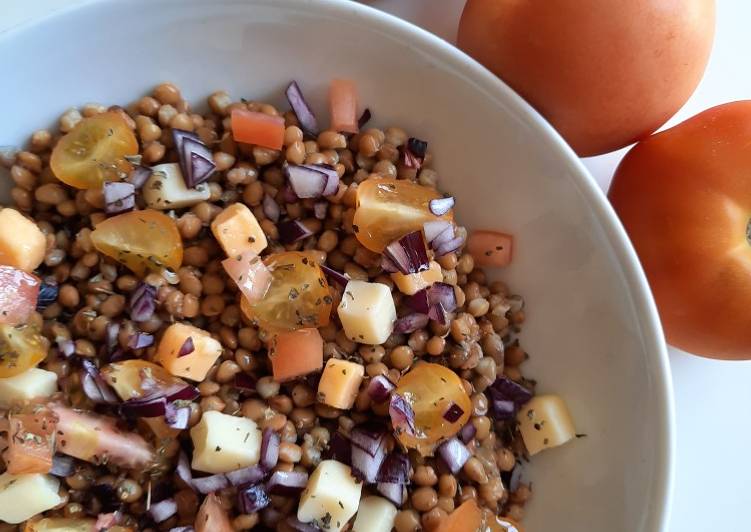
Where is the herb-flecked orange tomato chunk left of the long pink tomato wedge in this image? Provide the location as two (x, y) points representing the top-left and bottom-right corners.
(5, 407), (57, 475)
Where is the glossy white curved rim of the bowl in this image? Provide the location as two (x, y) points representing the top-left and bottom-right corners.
(0, 0), (676, 532)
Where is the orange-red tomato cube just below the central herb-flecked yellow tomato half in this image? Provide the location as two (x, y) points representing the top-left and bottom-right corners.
(271, 329), (323, 382)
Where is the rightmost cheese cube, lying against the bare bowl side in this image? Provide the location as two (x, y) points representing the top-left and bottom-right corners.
(516, 395), (576, 455)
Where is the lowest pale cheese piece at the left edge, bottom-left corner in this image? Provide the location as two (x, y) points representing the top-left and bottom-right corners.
(0, 473), (62, 524)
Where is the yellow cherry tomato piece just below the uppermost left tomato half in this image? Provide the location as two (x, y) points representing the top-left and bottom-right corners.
(91, 209), (183, 275)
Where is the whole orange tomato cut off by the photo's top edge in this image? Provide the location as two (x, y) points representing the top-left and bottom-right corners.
(458, 0), (715, 156)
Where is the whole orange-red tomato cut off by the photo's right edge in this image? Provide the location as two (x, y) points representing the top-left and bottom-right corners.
(609, 100), (751, 359)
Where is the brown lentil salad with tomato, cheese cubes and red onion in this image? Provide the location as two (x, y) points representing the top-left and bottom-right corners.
(0, 80), (574, 532)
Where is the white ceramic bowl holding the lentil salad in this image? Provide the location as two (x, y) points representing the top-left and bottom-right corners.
(0, 0), (674, 532)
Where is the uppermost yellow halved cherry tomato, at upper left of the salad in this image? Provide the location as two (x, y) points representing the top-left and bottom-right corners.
(50, 112), (138, 188)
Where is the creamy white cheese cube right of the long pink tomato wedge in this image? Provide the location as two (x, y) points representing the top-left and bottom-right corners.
(190, 410), (261, 473)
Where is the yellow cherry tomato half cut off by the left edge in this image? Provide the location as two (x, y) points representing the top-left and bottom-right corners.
(0, 325), (49, 378)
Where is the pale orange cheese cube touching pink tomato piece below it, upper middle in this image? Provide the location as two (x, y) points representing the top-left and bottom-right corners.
(211, 203), (268, 257)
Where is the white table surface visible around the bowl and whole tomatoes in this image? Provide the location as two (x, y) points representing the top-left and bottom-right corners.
(0, 0), (751, 532)
